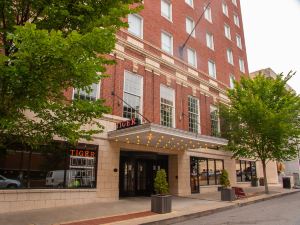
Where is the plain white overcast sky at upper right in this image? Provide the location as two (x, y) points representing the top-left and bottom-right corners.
(240, 0), (300, 94)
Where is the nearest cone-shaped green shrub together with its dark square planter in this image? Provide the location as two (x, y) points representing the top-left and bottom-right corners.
(151, 169), (172, 213)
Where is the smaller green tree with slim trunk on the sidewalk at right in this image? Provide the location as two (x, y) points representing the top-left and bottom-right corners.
(220, 73), (300, 193)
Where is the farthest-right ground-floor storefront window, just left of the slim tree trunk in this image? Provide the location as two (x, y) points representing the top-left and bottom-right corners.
(235, 160), (256, 182)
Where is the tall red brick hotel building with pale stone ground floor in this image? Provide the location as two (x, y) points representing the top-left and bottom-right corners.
(0, 0), (278, 214)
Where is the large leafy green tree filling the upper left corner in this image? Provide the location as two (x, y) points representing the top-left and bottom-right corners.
(0, 0), (141, 149)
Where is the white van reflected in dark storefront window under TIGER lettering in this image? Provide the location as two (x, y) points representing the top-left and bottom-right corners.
(46, 169), (95, 188)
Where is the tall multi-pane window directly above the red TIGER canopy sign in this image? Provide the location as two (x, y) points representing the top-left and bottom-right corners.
(123, 71), (143, 119)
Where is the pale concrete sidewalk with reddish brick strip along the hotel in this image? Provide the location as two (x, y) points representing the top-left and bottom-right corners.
(0, 187), (299, 225)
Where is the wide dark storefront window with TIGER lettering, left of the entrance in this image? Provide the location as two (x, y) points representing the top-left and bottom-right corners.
(0, 142), (98, 188)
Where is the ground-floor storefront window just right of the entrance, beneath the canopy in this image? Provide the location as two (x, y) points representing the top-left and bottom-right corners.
(190, 157), (224, 193)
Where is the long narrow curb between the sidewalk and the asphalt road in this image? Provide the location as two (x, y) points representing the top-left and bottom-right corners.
(140, 191), (300, 225)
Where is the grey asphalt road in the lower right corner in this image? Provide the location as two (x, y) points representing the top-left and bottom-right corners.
(176, 193), (300, 225)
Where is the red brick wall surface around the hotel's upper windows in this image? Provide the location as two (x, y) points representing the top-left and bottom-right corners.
(69, 0), (248, 135)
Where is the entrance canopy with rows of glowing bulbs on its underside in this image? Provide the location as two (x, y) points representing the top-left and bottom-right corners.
(108, 123), (228, 150)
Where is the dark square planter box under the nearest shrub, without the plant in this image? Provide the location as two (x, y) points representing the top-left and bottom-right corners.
(151, 195), (172, 214)
